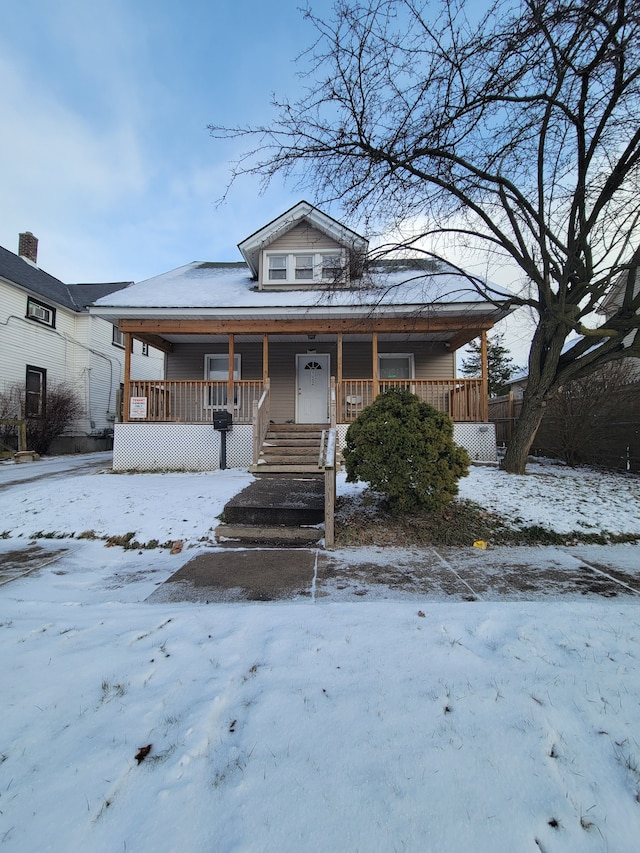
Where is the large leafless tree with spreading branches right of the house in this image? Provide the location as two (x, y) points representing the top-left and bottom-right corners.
(211, 0), (640, 473)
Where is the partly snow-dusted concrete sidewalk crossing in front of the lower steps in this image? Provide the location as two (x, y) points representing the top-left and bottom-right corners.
(147, 545), (640, 604)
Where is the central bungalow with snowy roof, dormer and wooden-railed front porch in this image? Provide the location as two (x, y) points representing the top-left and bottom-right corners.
(90, 201), (510, 470)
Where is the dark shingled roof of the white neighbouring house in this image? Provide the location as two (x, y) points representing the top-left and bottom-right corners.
(0, 241), (132, 313)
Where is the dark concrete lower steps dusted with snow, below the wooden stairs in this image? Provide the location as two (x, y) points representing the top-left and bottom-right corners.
(215, 466), (324, 546)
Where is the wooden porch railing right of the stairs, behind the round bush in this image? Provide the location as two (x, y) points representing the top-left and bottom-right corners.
(338, 379), (487, 423)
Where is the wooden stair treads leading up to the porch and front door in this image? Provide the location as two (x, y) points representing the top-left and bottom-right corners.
(249, 424), (328, 476)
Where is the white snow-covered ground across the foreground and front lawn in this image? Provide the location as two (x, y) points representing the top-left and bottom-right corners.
(0, 452), (640, 853)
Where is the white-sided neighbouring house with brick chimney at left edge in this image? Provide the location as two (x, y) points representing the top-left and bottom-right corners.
(0, 231), (164, 453)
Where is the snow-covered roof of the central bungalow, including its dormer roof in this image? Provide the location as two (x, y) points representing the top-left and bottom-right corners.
(91, 201), (512, 323)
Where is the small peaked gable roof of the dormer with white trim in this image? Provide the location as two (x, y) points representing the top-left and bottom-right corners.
(238, 201), (369, 278)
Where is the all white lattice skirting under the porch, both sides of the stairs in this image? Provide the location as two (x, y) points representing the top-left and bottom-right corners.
(113, 423), (497, 471)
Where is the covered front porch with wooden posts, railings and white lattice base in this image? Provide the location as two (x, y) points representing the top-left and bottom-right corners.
(114, 318), (496, 471)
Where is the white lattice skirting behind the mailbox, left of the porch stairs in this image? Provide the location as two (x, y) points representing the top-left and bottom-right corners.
(113, 423), (253, 471)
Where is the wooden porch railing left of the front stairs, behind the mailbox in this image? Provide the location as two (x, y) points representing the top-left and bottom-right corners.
(129, 379), (264, 424)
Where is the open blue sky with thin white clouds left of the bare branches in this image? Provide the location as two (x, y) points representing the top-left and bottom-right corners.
(0, 0), (528, 363)
